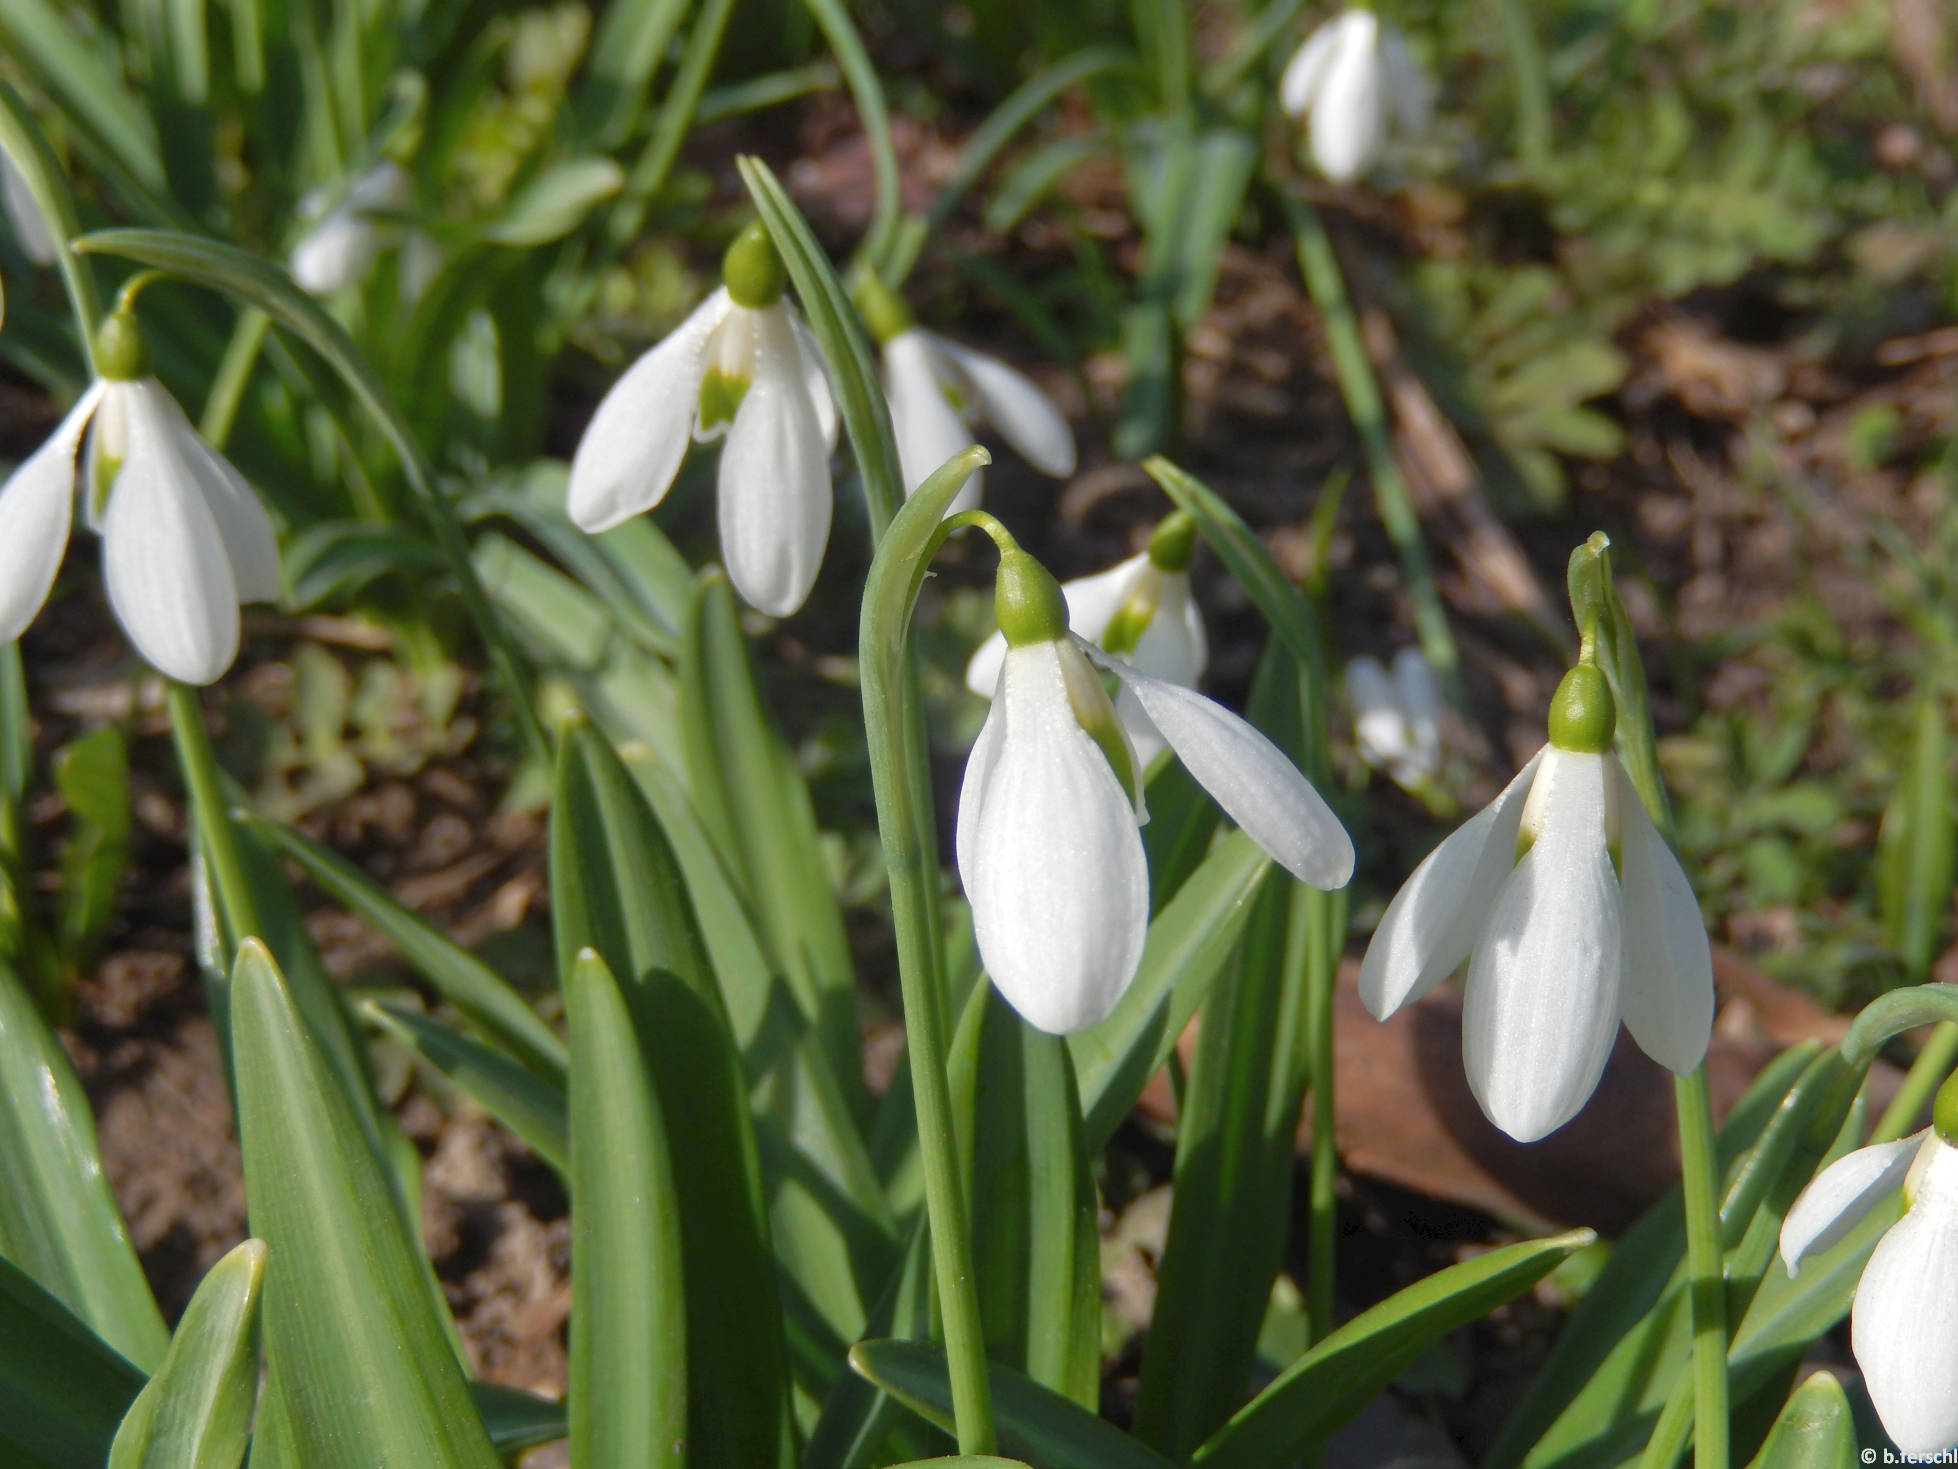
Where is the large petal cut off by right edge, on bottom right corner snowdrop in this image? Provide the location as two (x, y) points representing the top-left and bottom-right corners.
(1850, 1144), (1958, 1457)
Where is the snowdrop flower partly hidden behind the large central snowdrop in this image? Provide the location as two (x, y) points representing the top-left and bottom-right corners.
(965, 509), (1210, 770)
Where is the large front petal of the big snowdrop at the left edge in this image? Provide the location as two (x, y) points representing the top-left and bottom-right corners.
(102, 385), (239, 684)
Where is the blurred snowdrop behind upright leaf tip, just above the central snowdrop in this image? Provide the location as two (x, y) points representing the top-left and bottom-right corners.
(858, 276), (1075, 515)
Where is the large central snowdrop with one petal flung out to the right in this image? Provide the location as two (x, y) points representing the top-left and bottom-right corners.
(957, 543), (1353, 1034)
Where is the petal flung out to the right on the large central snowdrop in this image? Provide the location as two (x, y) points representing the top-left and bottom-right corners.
(1081, 644), (1353, 889)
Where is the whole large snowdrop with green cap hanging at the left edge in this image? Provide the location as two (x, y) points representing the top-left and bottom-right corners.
(0, 306), (278, 684)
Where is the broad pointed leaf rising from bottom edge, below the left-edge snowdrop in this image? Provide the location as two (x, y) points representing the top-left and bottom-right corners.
(231, 940), (497, 1469)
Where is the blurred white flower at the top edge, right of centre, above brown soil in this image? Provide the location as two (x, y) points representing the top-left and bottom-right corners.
(1279, 10), (1433, 184)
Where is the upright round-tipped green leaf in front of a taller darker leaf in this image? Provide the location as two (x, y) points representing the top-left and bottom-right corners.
(564, 948), (689, 1467)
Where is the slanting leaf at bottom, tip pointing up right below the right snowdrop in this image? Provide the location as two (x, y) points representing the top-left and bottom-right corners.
(1190, 1230), (1598, 1469)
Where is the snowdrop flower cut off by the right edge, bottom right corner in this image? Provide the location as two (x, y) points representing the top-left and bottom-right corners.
(1782, 1128), (1958, 1459)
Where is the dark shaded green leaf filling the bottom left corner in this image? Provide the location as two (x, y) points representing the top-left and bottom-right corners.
(0, 1259), (143, 1469)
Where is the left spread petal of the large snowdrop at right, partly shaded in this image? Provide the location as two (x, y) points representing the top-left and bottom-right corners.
(1347, 752), (1543, 1020)
